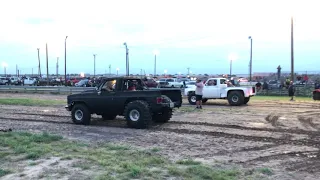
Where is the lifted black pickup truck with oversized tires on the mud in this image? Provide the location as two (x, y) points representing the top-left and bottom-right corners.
(66, 77), (182, 129)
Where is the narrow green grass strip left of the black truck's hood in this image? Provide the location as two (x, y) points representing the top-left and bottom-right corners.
(0, 98), (66, 106)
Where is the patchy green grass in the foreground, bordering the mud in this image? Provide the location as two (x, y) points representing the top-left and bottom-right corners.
(0, 132), (239, 180)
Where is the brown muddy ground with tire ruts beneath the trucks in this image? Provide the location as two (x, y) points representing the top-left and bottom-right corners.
(0, 94), (320, 179)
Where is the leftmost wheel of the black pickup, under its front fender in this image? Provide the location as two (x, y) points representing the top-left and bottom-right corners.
(71, 104), (91, 125)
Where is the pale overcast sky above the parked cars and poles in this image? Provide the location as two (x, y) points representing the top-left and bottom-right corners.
(0, 0), (320, 74)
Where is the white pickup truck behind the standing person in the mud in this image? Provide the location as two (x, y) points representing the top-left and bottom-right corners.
(184, 78), (256, 106)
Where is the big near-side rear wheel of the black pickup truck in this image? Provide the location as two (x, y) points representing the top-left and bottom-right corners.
(124, 101), (152, 129)
